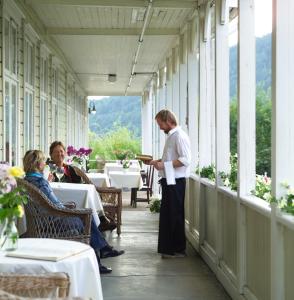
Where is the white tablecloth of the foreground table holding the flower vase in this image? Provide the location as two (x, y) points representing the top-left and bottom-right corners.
(0, 238), (103, 300)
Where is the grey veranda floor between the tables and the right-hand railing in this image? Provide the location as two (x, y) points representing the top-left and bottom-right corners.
(101, 193), (231, 300)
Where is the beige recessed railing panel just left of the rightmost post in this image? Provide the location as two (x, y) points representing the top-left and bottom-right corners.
(245, 207), (271, 300)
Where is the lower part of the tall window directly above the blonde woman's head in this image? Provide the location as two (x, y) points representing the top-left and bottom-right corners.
(24, 91), (34, 151)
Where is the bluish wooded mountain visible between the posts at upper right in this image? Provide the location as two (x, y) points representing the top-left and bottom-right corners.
(230, 34), (272, 98)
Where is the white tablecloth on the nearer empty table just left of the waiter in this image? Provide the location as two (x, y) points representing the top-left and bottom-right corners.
(109, 171), (143, 189)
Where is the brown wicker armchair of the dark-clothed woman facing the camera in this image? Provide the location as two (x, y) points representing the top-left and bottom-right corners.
(73, 167), (122, 235)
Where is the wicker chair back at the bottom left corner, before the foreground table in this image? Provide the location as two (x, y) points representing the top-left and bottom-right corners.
(0, 273), (70, 299)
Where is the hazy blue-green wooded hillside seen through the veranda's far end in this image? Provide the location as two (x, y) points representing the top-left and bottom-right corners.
(89, 96), (141, 138)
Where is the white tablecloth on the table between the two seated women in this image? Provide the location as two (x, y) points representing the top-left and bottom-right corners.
(50, 182), (103, 226)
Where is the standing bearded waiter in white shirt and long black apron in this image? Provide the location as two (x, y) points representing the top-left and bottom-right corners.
(148, 109), (191, 258)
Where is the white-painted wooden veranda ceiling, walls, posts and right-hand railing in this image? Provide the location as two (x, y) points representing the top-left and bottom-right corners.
(0, 0), (294, 300)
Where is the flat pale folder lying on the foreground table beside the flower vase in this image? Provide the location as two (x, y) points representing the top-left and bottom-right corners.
(5, 245), (89, 261)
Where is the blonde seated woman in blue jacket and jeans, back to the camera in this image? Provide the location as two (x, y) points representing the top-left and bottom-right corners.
(23, 150), (124, 274)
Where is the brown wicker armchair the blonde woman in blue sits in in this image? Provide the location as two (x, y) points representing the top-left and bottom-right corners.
(17, 178), (92, 244)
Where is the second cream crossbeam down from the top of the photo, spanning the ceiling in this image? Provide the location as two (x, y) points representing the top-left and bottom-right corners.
(46, 27), (180, 36)
